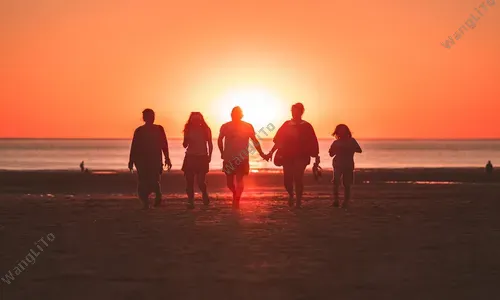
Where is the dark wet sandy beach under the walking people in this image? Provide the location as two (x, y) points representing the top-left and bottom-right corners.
(0, 169), (500, 300)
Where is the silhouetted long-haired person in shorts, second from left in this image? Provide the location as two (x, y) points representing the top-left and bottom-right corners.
(182, 112), (214, 208)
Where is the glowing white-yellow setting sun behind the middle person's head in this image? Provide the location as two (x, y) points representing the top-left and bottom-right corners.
(216, 88), (289, 131)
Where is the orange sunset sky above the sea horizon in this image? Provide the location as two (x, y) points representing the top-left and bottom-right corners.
(0, 0), (500, 138)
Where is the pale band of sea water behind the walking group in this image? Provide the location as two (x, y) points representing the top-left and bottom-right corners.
(0, 139), (500, 171)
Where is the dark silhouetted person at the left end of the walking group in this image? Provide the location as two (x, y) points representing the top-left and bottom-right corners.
(128, 108), (172, 209)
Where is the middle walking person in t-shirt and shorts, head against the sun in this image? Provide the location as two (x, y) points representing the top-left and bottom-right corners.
(217, 106), (268, 208)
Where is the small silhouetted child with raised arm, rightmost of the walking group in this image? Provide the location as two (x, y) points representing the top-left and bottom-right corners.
(329, 124), (362, 208)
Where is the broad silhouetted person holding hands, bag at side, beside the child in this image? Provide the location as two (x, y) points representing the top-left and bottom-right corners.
(268, 103), (320, 208)
